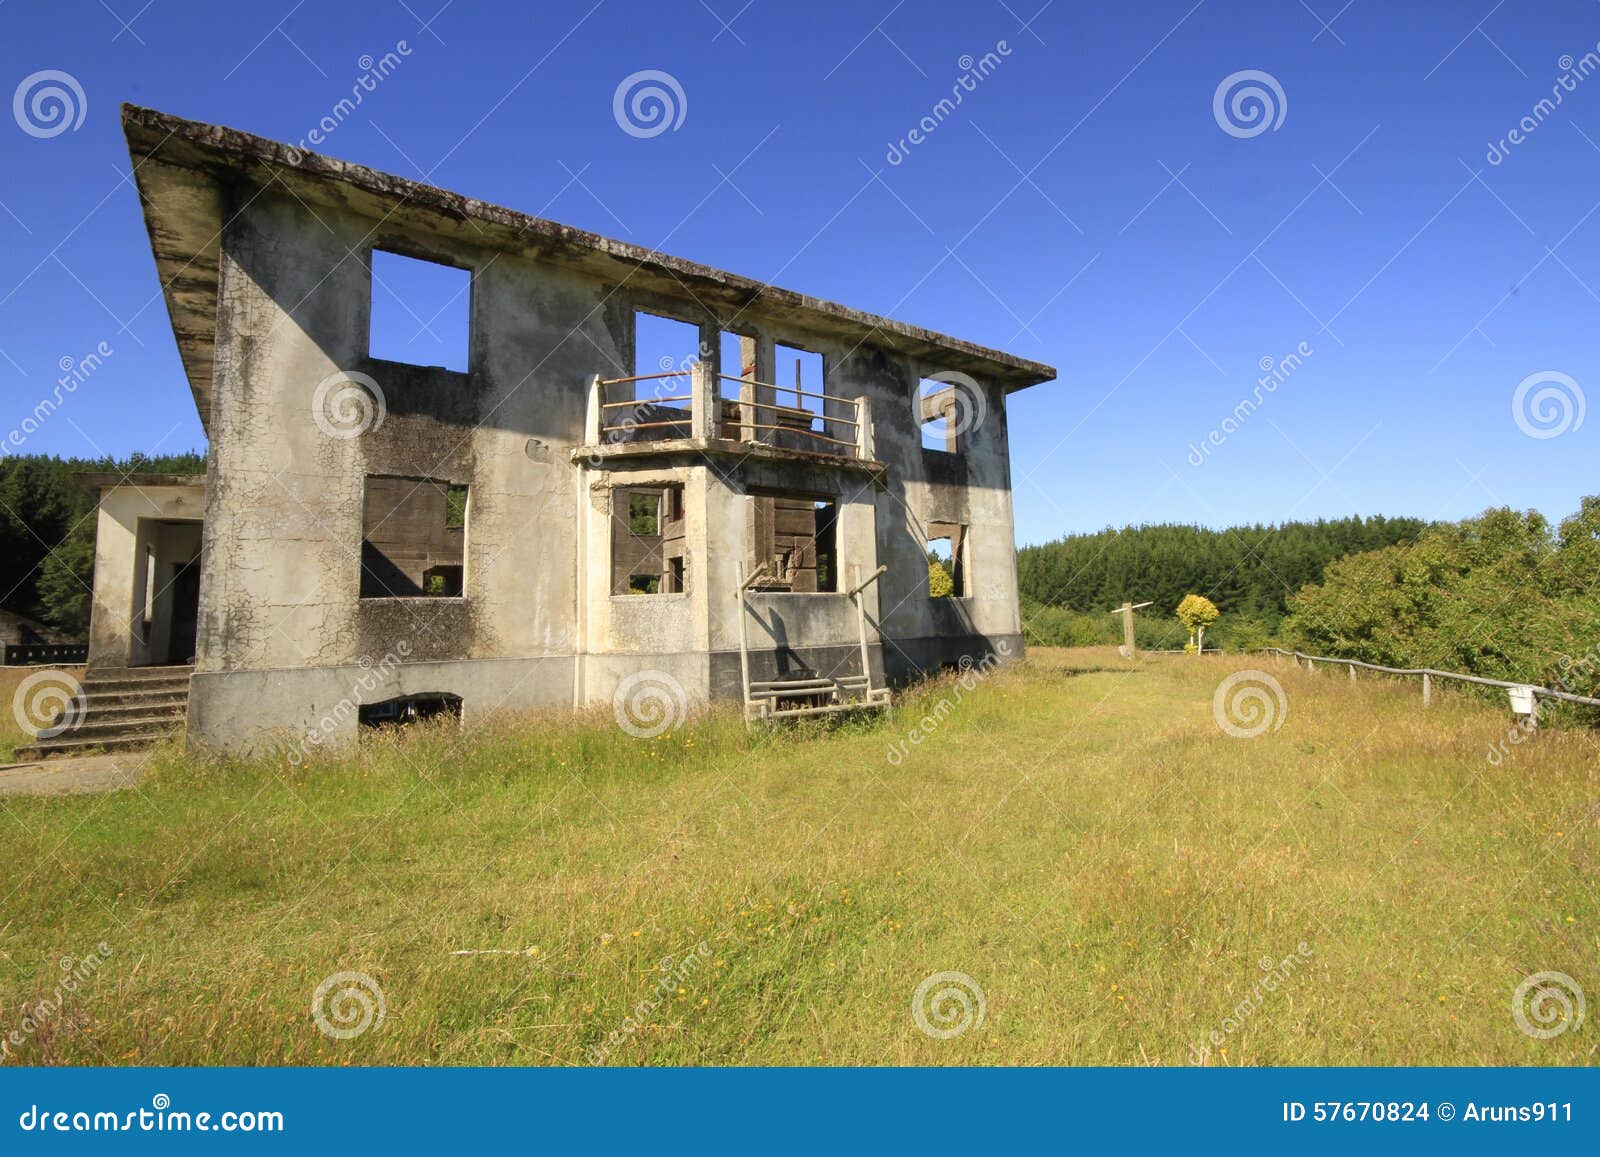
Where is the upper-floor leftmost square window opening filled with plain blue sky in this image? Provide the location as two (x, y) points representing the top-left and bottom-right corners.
(368, 250), (472, 373)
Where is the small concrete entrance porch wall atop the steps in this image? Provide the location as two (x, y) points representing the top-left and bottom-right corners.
(88, 485), (205, 667)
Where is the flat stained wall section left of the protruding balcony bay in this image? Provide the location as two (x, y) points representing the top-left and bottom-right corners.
(195, 190), (616, 731)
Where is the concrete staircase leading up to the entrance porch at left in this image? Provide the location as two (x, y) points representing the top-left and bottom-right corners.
(16, 667), (194, 763)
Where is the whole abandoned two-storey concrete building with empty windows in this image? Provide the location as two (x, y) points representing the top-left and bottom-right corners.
(31, 106), (1054, 761)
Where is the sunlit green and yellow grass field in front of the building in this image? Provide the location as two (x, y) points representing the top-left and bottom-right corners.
(0, 650), (1600, 1064)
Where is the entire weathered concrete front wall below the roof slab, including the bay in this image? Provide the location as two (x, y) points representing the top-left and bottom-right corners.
(187, 175), (1021, 743)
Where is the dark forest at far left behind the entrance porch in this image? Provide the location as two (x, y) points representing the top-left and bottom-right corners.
(0, 453), (205, 639)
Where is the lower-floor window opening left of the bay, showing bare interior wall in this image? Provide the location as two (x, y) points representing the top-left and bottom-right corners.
(360, 474), (469, 599)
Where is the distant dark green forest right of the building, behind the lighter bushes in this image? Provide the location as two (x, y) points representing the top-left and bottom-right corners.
(1018, 515), (1429, 650)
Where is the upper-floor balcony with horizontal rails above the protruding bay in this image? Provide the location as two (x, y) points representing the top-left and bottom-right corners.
(573, 362), (882, 470)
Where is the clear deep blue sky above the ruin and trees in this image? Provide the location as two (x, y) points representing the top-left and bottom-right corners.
(0, 0), (1600, 542)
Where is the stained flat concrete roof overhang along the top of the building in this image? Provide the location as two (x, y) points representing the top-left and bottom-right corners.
(122, 104), (1056, 435)
